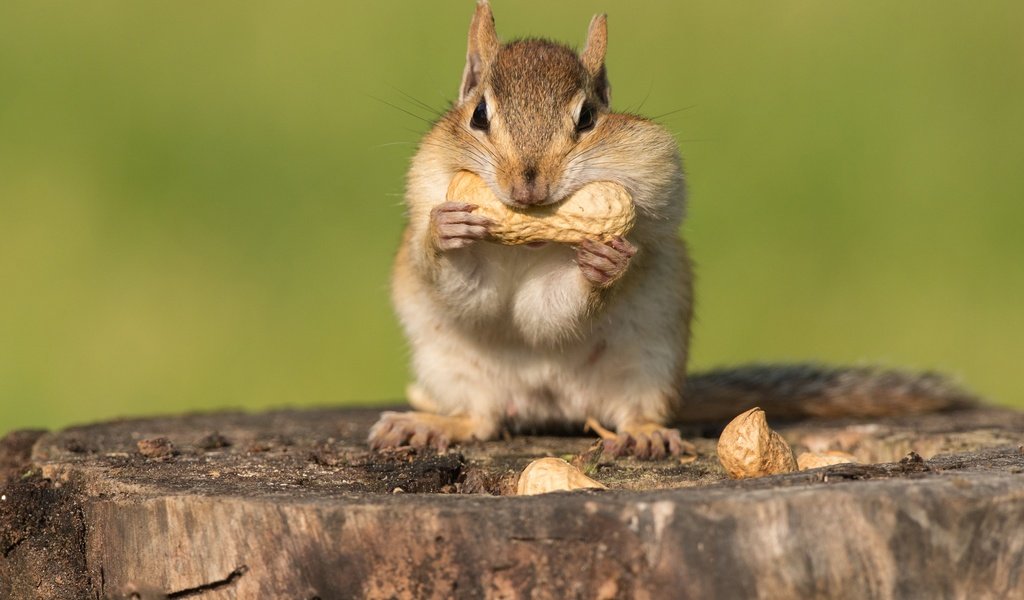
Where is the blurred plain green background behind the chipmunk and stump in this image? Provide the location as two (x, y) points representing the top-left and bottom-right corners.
(0, 0), (1024, 432)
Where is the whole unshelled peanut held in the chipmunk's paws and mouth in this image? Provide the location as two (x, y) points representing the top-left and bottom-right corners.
(446, 171), (636, 246)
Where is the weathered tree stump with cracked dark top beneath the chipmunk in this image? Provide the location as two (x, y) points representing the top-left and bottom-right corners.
(0, 408), (1024, 600)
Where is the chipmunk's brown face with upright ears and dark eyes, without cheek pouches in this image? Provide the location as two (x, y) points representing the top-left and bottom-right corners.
(452, 0), (610, 207)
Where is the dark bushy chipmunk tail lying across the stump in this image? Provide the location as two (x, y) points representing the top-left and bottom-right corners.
(678, 363), (980, 423)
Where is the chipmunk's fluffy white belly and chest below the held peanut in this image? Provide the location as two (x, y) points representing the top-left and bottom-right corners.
(398, 246), (667, 428)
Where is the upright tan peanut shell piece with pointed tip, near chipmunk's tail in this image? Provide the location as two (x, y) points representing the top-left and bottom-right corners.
(718, 409), (797, 479)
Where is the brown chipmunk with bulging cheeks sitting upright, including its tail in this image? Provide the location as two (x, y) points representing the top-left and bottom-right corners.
(369, 0), (973, 459)
